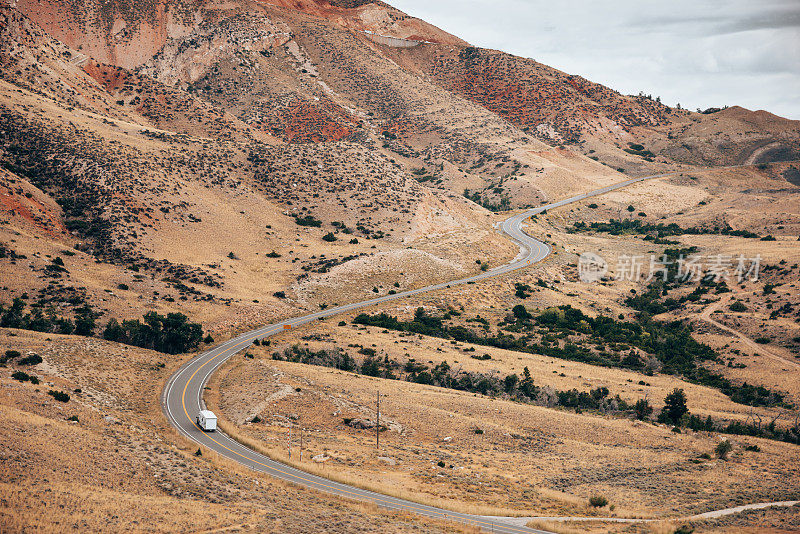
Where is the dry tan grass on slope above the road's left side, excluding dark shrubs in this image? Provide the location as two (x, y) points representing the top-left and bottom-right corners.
(0, 82), (516, 344)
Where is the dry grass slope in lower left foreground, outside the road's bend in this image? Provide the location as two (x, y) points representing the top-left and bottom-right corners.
(0, 329), (482, 533)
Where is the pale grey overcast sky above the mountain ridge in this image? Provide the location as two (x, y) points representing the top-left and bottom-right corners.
(387, 0), (800, 119)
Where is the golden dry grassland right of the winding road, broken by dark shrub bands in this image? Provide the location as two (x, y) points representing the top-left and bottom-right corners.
(206, 164), (800, 531)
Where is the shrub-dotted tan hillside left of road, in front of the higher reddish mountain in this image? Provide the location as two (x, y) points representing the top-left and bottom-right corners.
(2, 4), (512, 336)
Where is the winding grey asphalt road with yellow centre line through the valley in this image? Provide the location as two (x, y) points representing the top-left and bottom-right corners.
(162, 172), (692, 534)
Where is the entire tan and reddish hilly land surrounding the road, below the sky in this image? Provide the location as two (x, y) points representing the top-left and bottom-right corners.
(0, 0), (800, 533)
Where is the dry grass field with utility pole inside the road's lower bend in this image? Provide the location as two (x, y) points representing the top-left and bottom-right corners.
(212, 346), (798, 517)
